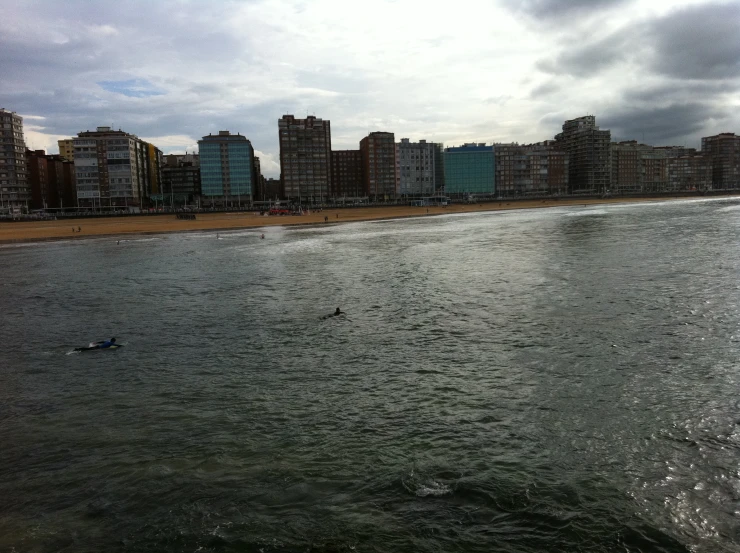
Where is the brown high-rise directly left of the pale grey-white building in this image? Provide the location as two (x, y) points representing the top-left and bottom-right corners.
(360, 132), (399, 201)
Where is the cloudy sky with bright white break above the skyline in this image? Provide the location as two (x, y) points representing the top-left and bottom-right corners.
(0, 0), (740, 177)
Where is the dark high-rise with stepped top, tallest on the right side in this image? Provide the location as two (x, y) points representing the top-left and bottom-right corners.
(555, 115), (611, 194)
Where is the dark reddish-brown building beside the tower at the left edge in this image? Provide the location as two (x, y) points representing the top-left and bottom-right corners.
(26, 150), (77, 209)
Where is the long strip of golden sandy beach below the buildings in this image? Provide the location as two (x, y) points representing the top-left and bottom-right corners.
(0, 197), (736, 243)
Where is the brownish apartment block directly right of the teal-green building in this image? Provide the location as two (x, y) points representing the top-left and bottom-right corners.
(493, 141), (568, 198)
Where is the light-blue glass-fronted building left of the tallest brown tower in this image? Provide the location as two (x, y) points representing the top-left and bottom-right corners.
(198, 131), (254, 207)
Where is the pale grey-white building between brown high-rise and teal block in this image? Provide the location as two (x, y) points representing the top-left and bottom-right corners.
(396, 138), (437, 196)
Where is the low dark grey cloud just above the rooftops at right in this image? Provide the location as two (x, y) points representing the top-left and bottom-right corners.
(598, 102), (729, 147)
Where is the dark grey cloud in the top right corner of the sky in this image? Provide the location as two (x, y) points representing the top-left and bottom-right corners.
(645, 2), (740, 79)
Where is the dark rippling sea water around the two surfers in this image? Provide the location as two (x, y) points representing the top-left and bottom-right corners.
(0, 201), (740, 553)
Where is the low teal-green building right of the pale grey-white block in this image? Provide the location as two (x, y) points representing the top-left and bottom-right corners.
(444, 143), (496, 197)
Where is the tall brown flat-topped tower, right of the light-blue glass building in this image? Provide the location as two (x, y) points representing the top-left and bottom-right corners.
(278, 115), (332, 203)
